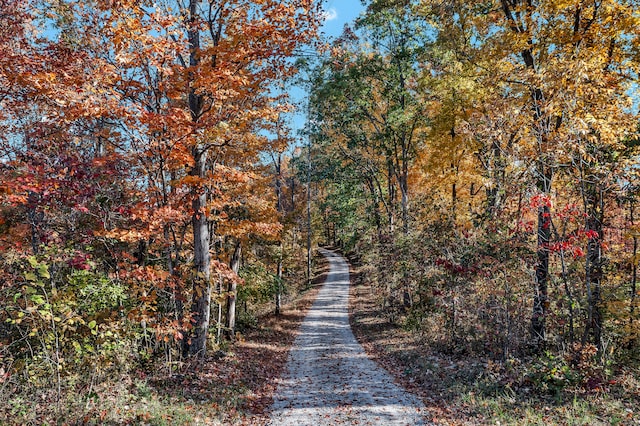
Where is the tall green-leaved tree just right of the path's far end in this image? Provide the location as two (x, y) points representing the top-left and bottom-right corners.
(312, 2), (428, 238)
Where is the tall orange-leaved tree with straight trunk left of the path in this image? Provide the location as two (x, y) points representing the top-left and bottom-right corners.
(93, 0), (320, 355)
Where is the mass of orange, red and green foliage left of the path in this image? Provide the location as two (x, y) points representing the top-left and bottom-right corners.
(0, 0), (320, 402)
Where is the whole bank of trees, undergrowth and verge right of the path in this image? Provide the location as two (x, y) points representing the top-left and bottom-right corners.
(310, 0), (640, 424)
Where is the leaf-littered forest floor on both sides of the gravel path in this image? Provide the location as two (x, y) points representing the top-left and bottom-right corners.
(6, 248), (640, 425)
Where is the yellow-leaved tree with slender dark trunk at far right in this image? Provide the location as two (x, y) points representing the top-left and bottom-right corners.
(422, 0), (636, 347)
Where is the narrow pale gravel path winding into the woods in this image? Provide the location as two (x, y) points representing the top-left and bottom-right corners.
(271, 250), (425, 426)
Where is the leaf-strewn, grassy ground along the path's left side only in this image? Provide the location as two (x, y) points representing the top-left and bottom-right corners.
(22, 256), (329, 426)
